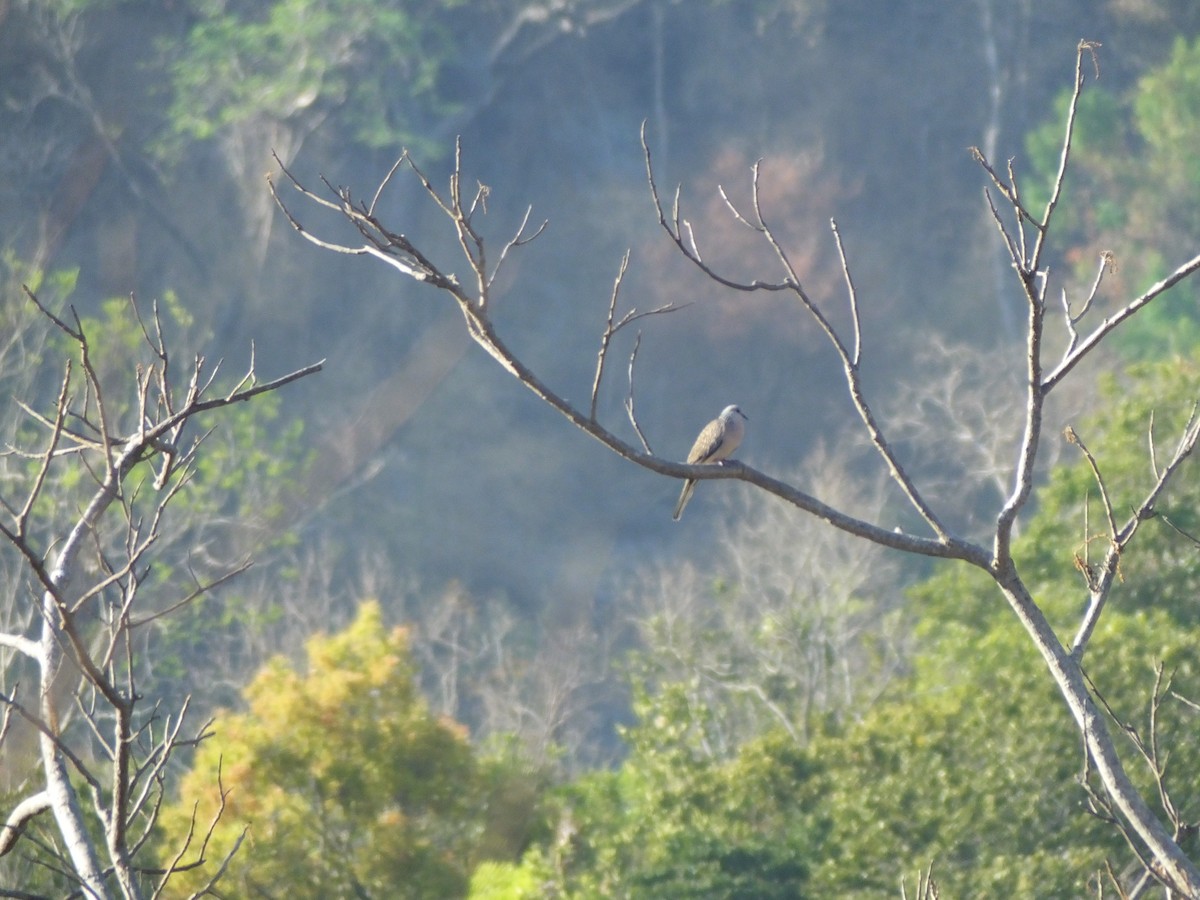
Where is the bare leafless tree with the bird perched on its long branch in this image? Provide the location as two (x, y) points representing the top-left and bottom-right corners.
(272, 42), (1200, 898)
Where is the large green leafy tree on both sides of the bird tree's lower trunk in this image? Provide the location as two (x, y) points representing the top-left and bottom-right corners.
(811, 360), (1200, 896)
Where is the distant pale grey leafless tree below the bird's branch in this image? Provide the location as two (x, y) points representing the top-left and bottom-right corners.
(628, 446), (906, 758)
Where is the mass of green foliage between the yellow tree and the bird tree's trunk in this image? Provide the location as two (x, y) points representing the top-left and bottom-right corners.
(535, 609), (1113, 898)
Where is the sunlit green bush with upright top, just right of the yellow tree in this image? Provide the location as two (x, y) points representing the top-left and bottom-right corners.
(512, 688), (820, 898)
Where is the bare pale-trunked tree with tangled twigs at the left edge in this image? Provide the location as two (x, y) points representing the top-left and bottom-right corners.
(0, 289), (320, 898)
